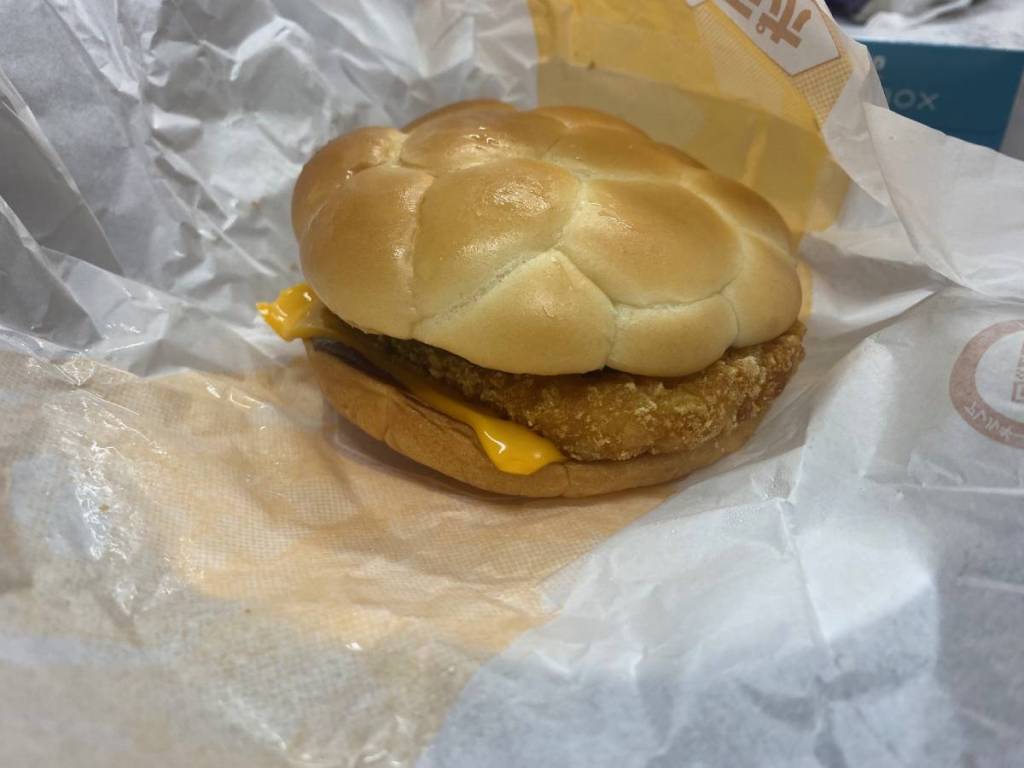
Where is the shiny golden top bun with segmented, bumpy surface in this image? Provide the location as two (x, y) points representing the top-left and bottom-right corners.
(292, 101), (801, 376)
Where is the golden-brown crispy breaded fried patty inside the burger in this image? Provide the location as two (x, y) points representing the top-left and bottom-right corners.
(354, 323), (804, 461)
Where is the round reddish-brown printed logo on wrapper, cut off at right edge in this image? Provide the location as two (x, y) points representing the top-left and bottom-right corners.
(949, 319), (1024, 449)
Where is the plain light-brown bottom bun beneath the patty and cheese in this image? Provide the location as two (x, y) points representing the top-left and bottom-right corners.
(305, 341), (761, 498)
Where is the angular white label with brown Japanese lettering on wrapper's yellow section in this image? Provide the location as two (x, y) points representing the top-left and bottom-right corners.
(687, 0), (839, 75)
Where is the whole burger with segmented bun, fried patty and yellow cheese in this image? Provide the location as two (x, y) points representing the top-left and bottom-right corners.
(260, 100), (804, 497)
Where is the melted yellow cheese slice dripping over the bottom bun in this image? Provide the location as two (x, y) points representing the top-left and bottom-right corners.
(257, 283), (565, 475)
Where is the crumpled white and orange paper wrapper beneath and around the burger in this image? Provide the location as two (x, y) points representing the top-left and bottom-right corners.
(0, 0), (1024, 767)
